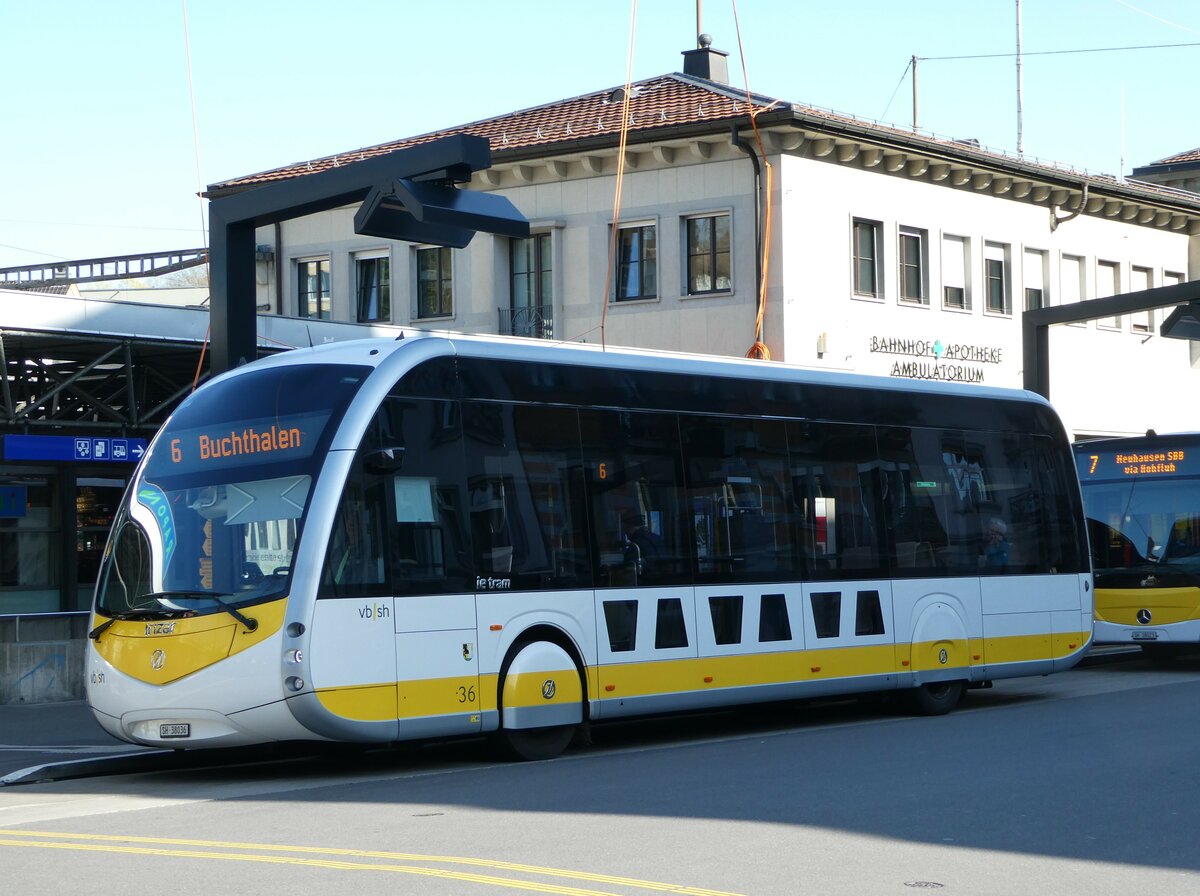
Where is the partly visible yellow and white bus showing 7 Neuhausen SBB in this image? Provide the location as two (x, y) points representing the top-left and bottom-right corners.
(1075, 433), (1200, 657)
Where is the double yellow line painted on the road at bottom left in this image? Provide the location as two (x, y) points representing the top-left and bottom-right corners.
(0, 830), (737, 896)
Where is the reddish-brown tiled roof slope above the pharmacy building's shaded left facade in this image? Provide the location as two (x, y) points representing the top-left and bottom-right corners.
(210, 74), (775, 192)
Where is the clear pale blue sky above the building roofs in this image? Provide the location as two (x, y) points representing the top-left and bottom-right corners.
(0, 0), (1200, 267)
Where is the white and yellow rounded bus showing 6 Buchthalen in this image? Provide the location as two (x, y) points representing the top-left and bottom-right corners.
(88, 335), (1092, 758)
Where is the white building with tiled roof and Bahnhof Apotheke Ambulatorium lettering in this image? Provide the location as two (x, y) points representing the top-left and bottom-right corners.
(209, 49), (1200, 435)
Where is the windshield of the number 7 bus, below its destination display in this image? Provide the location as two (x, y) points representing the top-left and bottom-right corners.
(1084, 479), (1200, 577)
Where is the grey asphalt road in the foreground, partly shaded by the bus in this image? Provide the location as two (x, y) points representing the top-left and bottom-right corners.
(0, 656), (1200, 896)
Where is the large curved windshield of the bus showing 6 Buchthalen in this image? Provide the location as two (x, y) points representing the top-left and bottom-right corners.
(96, 365), (371, 617)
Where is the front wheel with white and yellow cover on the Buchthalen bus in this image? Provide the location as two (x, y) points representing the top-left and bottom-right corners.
(496, 626), (588, 760)
